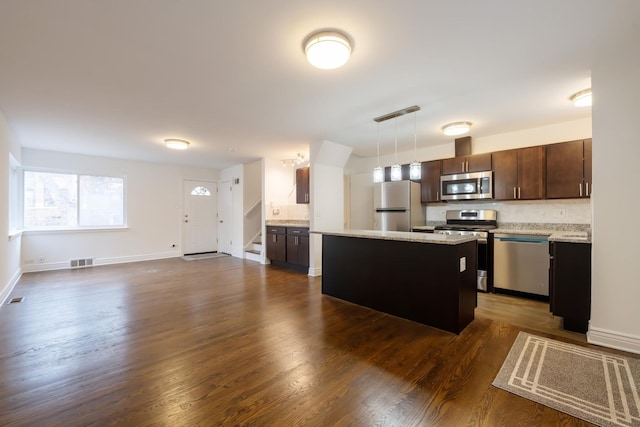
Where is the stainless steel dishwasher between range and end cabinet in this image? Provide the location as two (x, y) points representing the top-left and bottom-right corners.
(493, 233), (549, 297)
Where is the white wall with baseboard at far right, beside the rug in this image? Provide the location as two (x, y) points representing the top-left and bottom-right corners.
(588, 2), (640, 353)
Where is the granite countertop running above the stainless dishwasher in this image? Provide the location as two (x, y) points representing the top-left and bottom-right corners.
(491, 223), (591, 243)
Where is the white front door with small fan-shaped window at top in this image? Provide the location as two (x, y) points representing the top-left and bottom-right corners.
(183, 179), (218, 254)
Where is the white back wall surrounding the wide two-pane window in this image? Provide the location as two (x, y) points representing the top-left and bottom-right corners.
(22, 149), (218, 271)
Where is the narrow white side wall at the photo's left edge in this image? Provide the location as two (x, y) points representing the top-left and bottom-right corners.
(0, 108), (22, 306)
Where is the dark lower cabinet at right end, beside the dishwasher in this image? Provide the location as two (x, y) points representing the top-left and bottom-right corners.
(549, 242), (591, 333)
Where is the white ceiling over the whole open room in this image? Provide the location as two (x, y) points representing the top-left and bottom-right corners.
(0, 0), (616, 168)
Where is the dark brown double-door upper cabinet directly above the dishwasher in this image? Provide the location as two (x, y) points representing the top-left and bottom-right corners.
(493, 146), (545, 200)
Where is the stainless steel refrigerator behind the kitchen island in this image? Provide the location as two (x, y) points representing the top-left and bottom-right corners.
(373, 181), (425, 231)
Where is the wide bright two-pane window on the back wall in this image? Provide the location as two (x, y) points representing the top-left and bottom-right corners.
(24, 171), (124, 229)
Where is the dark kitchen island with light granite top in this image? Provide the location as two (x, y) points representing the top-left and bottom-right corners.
(313, 230), (477, 334)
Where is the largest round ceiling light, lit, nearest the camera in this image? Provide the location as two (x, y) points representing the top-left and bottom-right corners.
(304, 31), (351, 70)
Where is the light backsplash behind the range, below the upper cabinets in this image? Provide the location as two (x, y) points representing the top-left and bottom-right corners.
(426, 199), (591, 225)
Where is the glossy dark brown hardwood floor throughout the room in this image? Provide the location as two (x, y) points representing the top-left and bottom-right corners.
(0, 257), (624, 426)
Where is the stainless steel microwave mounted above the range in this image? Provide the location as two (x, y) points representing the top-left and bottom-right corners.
(440, 171), (493, 200)
